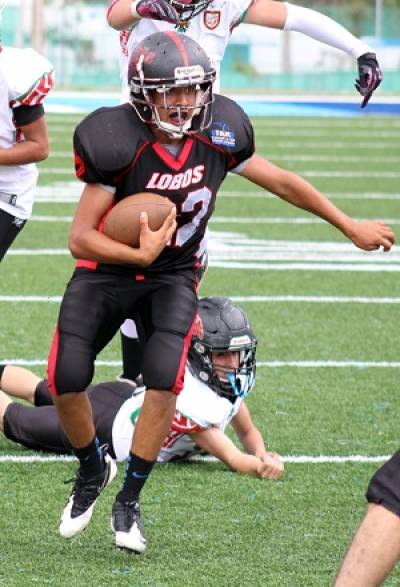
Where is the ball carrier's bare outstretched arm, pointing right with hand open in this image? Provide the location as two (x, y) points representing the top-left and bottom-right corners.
(240, 155), (395, 251)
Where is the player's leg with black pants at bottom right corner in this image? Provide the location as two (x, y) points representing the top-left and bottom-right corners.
(334, 450), (400, 587)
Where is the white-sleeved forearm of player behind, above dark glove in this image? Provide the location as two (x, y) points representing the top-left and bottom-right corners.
(284, 2), (371, 59)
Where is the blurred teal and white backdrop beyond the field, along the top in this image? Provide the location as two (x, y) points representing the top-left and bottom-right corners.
(1, 0), (400, 95)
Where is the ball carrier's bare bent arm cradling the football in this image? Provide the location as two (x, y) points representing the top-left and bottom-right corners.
(69, 184), (176, 267)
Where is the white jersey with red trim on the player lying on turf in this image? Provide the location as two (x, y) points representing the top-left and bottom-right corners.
(112, 367), (243, 463)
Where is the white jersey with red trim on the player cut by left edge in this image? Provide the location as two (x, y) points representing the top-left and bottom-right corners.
(0, 47), (53, 220)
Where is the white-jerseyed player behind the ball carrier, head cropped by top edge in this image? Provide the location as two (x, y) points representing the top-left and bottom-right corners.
(108, 0), (382, 380)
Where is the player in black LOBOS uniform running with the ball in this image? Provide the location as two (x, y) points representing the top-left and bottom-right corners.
(48, 31), (394, 552)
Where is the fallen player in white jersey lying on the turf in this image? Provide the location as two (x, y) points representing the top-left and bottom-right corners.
(0, 297), (283, 479)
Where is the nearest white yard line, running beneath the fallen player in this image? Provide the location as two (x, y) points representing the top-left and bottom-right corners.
(0, 454), (390, 465)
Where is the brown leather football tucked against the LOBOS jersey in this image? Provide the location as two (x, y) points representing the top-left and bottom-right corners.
(104, 192), (174, 247)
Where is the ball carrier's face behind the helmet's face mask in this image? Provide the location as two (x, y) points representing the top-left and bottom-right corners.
(152, 86), (198, 128)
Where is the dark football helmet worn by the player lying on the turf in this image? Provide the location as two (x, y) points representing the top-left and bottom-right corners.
(189, 297), (257, 401)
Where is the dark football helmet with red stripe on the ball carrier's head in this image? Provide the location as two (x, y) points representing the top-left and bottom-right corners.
(128, 31), (216, 138)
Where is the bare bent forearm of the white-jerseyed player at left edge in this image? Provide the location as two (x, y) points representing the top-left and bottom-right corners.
(0, 116), (49, 165)
